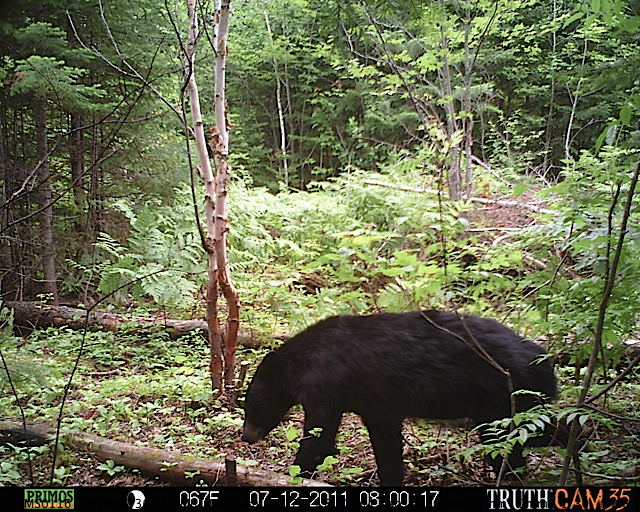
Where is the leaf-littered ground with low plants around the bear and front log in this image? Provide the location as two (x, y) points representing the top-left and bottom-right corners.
(5, 199), (640, 487)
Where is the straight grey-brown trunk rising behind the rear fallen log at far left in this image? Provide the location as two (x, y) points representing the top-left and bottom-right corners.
(35, 98), (59, 304)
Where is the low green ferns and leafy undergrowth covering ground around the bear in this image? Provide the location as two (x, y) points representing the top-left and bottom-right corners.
(0, 165), (640, 486)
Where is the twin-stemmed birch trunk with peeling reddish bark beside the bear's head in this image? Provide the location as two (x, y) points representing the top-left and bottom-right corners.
(183, 0), (240, 398)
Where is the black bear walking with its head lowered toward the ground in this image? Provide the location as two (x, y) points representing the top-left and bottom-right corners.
(242, 311), (557, 486)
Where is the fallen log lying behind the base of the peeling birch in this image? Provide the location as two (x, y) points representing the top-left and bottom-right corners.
(5, 301), (278, 347)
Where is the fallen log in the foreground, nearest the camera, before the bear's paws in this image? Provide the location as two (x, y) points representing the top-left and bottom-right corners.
(0, 420), (329, 487)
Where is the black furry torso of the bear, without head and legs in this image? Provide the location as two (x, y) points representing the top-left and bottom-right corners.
(278, 311), (556, 419)
